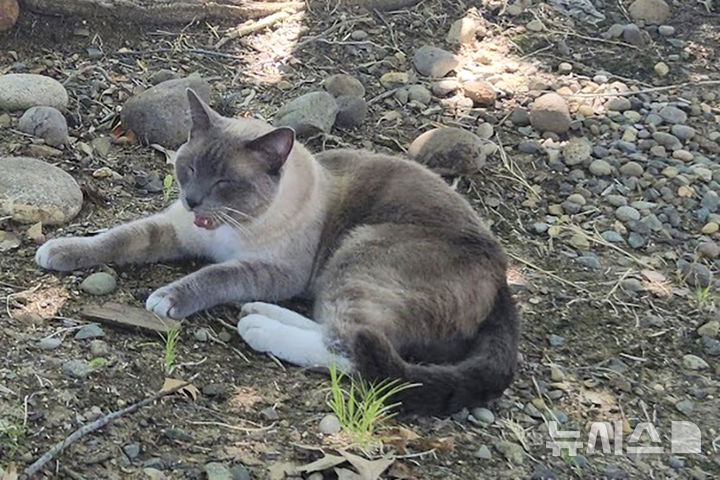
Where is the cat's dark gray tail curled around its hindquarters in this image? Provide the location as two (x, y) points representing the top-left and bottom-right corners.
(353, 285), (519, 415)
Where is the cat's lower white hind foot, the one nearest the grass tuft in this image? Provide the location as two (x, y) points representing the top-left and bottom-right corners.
(237, 313), (352, 372)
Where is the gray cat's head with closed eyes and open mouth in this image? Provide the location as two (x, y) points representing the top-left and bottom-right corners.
(175, 89), (295, 229)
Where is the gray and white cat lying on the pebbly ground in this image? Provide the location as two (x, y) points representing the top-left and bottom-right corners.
(36, 90), (519, 414)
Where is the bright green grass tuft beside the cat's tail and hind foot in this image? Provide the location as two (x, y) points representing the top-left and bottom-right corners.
(327, 364), (419, 447)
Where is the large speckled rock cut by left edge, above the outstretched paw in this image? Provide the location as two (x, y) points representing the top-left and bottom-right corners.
(0, 157), (83, 225)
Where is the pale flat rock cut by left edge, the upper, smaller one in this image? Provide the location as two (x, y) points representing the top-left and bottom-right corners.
(0, 73), (68, 111)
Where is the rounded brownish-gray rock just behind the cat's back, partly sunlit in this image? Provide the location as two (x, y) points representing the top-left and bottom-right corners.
(408, 127), (485, 175)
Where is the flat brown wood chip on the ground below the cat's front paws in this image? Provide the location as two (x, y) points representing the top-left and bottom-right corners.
(80, 302), (180, 333)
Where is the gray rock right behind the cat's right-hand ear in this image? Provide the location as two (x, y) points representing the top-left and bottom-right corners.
(274, 92), (338, 136)
